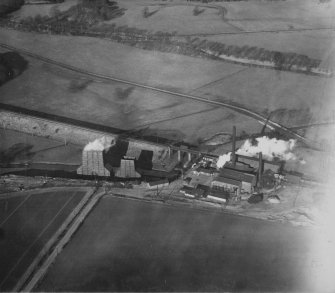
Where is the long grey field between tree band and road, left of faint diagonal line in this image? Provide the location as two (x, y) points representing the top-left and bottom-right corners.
(0, 28), (244, 91)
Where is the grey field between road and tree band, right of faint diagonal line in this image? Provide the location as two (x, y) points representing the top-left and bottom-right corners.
(197, 68), (335, 127)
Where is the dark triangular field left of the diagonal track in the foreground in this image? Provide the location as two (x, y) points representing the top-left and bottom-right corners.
(0, 188), (86, 292)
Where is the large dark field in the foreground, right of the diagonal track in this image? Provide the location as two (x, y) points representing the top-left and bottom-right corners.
(37, 197), (322, 292)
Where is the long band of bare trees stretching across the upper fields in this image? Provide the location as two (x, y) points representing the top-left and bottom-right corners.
(0, 16), (321, 75)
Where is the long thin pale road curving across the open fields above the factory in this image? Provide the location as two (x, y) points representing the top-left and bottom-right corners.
(0, 43), (319, 149)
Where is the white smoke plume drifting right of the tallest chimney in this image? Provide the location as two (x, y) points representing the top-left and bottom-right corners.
(236, 136), (297, 161)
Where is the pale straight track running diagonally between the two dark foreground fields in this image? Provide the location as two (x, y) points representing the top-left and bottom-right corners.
(12, 189), (95, 292)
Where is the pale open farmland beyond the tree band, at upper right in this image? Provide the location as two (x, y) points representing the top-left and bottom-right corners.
(109, 0), (335, 68)
